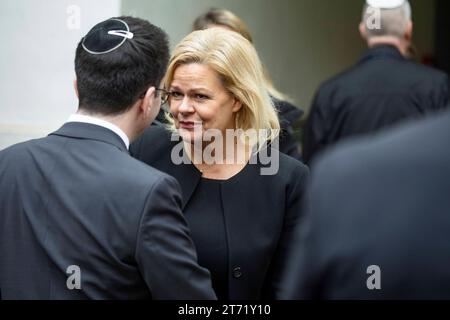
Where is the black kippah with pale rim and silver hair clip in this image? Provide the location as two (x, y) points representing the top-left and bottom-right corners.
(82, 19), (134, 54)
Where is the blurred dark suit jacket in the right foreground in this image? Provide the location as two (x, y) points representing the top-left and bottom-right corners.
(282, 109), (450, 299)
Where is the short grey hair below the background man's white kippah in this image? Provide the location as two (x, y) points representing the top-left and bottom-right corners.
(362, 0), (412, 39)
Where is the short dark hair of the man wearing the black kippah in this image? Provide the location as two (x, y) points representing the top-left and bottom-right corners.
(75, 17), (169, 115)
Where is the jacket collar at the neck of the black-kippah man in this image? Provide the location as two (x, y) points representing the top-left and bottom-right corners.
(50, 122), (128, 153)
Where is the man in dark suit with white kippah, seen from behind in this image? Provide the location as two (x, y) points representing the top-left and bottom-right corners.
(303, 0), (450, 164)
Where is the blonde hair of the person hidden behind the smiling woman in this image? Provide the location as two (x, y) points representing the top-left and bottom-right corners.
(193, 8), (291, 101)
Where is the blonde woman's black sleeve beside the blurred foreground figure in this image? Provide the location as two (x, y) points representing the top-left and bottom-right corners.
(266, 166), (309, 299)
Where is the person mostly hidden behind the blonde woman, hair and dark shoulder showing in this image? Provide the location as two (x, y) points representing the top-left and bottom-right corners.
(185, 9), (303, 160)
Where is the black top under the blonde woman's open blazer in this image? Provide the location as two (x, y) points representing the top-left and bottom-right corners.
(184, 178), (229, 300)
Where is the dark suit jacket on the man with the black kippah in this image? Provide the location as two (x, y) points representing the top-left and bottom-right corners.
(0, 123), (215, 299)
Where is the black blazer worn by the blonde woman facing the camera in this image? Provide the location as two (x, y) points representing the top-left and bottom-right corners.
(131, 125), (309, 300)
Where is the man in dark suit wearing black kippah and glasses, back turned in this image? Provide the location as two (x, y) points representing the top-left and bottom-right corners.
(0, 17), (215, 299)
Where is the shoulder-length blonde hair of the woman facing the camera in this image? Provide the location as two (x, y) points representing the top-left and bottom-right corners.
(164, 28), (280, 146)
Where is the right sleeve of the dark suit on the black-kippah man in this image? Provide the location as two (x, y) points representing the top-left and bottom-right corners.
(136, 176), (216, 300)
